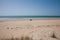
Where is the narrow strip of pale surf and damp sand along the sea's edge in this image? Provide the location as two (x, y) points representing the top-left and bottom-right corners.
(0, 18), (60, 22)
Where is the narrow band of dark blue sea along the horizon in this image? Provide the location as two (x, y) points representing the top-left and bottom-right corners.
(0, 16), (60, 18)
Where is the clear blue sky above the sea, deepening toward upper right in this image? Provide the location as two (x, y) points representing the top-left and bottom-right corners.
(0, 0), (60, 16)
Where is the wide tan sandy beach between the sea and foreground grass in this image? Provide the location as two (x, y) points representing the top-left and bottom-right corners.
(0, 18), (60, 40)
